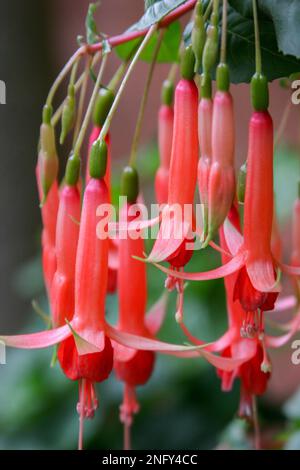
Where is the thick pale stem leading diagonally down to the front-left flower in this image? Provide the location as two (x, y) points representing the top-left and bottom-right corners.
(97, 24), (157, 140)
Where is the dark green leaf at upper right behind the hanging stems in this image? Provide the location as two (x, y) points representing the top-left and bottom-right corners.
(184, 1), (300, 83)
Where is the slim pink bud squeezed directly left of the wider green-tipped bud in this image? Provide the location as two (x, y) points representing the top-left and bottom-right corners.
(198, 76), (213, 239)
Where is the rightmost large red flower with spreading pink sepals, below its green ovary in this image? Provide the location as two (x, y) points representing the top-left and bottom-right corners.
(156, 111), (300, 311)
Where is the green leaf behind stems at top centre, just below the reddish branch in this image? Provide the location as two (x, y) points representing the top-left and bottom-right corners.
(115, 21), (181, 63)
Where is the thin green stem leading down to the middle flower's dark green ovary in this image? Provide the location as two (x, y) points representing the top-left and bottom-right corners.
(129, 29), (165, 166)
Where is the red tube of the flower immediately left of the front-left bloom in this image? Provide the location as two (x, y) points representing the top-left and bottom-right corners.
(50, 184), (81, 327)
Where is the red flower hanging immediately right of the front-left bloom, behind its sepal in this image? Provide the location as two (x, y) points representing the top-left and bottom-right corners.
(114, 180), (166, 449)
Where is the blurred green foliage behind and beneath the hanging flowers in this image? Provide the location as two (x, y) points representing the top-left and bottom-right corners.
(0, 147), (300, 449)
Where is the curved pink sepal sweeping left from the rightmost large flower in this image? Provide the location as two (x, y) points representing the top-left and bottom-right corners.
(153, 253), (245, 281)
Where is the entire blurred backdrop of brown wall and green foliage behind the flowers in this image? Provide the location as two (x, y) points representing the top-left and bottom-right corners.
(0, 0), (300, 449)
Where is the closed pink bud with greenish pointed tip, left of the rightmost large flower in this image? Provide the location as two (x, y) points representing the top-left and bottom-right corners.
(204, 64), (235, 246)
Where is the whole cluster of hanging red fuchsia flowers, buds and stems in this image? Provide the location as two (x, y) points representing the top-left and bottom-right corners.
(0, 0), (300, 449)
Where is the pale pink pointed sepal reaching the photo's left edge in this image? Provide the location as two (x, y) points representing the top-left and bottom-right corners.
(0, 325), (71, 349)
